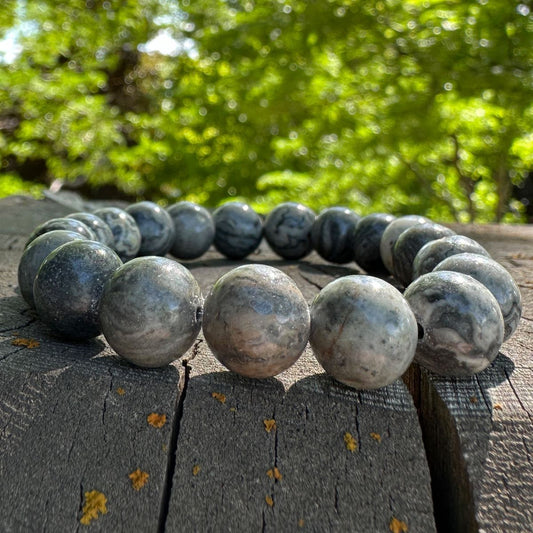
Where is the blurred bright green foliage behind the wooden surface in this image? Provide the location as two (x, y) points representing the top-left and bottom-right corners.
(0, 0), (533, 222)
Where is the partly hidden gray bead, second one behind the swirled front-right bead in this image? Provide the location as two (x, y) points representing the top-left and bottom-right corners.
(413, 235), (490, 279)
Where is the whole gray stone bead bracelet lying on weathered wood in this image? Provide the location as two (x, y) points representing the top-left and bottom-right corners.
(18, 202), (521, 389)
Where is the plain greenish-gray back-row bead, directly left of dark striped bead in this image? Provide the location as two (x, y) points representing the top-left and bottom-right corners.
(167, 202), (215, 259)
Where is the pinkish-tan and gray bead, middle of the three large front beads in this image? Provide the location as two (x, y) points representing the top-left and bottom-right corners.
(203, 264), (309, 378)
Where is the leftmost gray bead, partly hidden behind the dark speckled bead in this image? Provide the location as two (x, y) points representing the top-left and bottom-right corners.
(18, 230), (86, 307)
